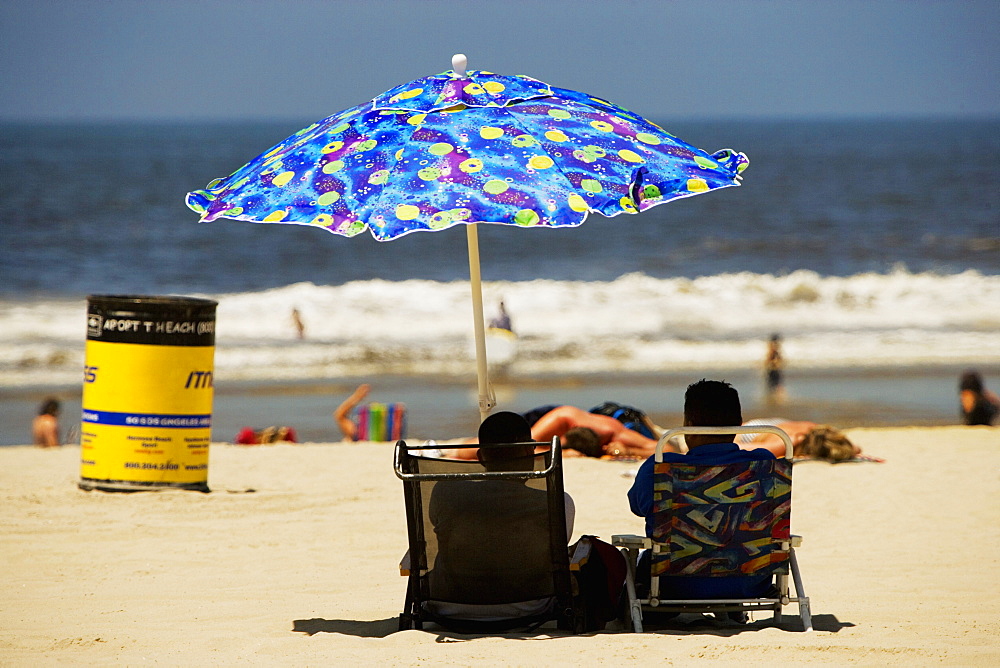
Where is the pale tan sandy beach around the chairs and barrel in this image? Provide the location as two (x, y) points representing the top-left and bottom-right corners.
(0, 427), (1000, 666)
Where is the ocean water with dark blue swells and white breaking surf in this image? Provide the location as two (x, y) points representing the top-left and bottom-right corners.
(0, 118), (1000, 443)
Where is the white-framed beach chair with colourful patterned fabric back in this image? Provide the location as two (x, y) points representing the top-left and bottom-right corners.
(612, 426), (812, 633)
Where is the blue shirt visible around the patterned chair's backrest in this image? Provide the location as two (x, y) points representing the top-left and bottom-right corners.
(628, 443), (774, 598)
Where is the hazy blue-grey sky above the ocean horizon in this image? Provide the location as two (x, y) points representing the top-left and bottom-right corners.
(0, 0), (1000, 122)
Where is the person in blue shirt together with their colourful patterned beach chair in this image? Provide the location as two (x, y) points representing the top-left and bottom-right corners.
(612, 380), (812, 632)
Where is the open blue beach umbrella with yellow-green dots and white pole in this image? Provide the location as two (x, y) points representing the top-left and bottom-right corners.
(187, 54), (749, 416)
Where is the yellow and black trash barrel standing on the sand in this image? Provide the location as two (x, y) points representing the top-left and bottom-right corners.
(79, 295), (218, 492)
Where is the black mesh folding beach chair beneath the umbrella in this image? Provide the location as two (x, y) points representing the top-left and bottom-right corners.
(394, 438), (585, 633)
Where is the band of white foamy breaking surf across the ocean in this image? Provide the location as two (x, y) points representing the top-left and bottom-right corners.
(0, 269), (1000, 386)
